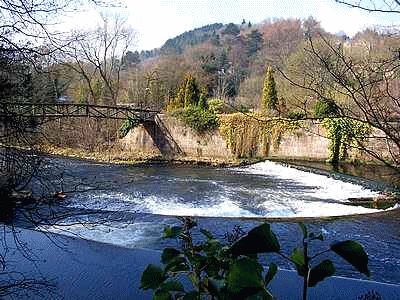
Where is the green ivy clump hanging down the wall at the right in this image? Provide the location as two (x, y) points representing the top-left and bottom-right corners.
(322, 117), (371, 163)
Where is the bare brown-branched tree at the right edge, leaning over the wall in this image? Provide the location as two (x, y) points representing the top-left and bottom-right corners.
(280, 32), (400, 169)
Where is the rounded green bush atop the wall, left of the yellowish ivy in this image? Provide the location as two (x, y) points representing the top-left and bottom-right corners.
(173, 106), (218, 133)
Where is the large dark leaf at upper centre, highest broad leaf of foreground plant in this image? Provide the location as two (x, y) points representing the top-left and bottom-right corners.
(230, 223), (280, 255)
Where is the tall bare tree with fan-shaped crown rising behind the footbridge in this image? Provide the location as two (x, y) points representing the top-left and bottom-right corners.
(61, 15), (135, 104)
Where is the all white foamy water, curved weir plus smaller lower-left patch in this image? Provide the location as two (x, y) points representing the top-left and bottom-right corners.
(42, 161), (396, 247)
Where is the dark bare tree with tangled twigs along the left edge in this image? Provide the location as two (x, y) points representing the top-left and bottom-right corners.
(0, 0), (131, 298)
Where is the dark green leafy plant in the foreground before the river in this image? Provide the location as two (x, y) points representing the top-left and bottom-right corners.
(141, 218), (370, 300)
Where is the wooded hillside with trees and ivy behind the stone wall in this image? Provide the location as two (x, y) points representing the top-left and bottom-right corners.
(0, 3), (400, 168)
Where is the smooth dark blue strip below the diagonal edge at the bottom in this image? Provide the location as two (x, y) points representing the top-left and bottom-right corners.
(0, 227), (400, 300)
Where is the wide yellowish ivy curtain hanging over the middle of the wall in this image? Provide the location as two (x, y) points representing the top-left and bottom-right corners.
(219, 113), (300, 158)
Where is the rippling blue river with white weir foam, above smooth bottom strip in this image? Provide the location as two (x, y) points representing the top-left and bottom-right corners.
(35, 159), (400, 283)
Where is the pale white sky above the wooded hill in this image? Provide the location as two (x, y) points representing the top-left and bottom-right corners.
(65, 0), (398, 50)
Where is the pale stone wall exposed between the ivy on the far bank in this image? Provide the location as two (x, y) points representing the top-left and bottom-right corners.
(119, 115), (388, 160)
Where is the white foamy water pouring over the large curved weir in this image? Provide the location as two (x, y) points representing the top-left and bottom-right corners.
(61, 161), (379, 218)
